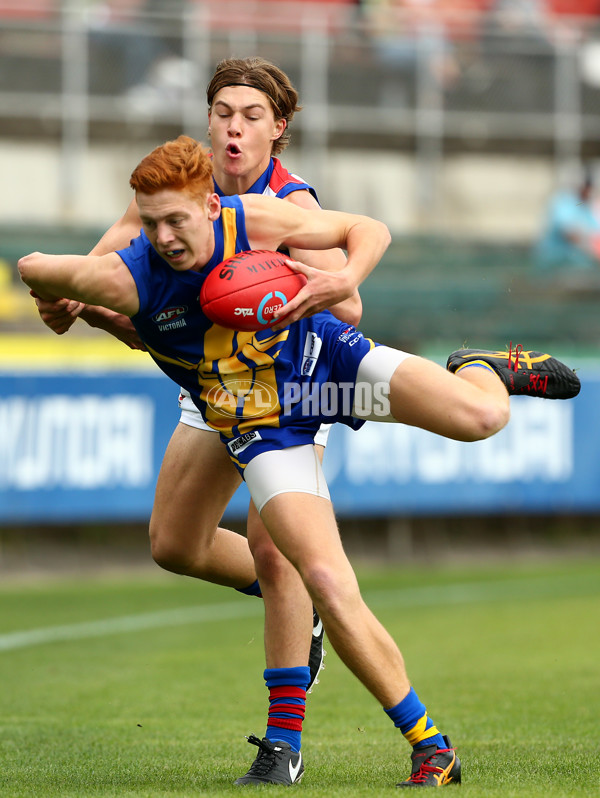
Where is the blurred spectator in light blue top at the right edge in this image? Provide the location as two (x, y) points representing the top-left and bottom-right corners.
(536, 172), (600, 271)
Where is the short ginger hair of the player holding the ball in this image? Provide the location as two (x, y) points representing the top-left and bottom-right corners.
(129, 136), (214, 202)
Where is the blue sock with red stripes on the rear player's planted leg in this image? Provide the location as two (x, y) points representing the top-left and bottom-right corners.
(264, 665), (310, 752)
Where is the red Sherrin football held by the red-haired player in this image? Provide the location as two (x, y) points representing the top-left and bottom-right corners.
(200, 249), (306, 332)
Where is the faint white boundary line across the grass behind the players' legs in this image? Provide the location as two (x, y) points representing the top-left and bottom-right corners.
(0, 576), (599, 652)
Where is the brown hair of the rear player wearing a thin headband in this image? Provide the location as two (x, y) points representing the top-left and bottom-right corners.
(206, 57), (302, 155)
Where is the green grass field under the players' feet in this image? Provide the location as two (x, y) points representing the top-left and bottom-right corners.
(0, 559), (600, 798)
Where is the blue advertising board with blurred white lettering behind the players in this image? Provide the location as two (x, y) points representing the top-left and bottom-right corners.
(0, 370), (600, 524)
